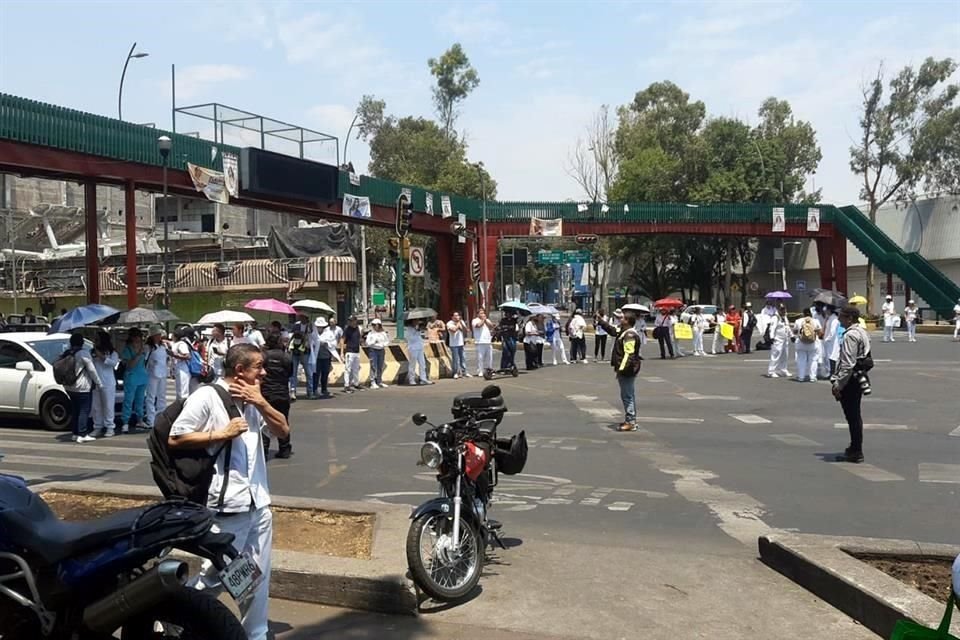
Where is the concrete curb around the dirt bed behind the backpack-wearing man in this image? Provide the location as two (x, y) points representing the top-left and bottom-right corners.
(31, 480), (418, 615)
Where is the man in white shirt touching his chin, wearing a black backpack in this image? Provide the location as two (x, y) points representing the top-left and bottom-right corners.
(168, 345), (290, 640)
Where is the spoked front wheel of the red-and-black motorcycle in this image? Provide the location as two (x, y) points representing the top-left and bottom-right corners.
(407, 512), (485, 602)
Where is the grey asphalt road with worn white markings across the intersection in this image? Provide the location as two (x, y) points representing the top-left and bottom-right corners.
(0, 336), (960, 638)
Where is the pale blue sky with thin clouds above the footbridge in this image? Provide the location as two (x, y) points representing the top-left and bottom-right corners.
(0, 0), (960, 204)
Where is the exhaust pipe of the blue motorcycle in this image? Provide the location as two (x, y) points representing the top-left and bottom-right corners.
(83, 560), (190, 633)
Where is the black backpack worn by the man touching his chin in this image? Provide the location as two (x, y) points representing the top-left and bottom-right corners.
(147, 385), (240, 509)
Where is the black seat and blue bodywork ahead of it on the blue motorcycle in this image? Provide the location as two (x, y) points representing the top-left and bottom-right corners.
(0, 484), (143, 565)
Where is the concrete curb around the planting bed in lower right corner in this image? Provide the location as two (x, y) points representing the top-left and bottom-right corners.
(759, 534), (960, 638)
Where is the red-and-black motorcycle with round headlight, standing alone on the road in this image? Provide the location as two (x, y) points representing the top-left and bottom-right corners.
(406, 385), (527, 602)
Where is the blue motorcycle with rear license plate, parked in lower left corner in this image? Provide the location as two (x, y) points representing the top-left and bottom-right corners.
(0, 474), (253, 640)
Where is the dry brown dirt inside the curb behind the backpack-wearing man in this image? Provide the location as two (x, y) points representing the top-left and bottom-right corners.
(41, 491), (374, 560)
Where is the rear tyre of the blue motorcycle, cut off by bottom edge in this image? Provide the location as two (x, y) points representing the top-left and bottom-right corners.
(120, 588), (247, 640)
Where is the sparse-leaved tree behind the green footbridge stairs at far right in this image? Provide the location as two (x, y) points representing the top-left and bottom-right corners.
(850, 58), (960, 312)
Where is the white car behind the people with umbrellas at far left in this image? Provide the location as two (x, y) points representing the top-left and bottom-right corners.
(0, 332), (85, 431)
